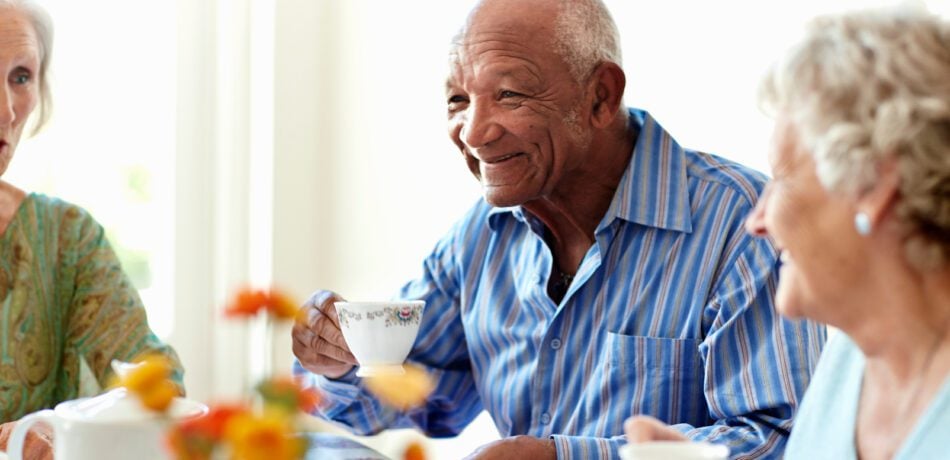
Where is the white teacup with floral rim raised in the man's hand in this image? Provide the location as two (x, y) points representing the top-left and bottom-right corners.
(333, 300), (426, 377)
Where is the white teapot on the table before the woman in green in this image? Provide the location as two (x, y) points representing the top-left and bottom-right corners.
(7, 388), (208, 460)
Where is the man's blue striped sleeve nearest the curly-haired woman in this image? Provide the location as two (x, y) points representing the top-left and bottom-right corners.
(673, 235), (826, 459)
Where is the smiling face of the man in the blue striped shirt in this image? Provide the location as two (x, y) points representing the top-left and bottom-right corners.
(446, 3), (590, 206)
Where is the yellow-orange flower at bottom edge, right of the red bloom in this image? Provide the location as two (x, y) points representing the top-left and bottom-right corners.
(224, 413), (307, 460)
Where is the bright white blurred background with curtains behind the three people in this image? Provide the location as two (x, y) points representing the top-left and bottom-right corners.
(4, 0), (950, 458)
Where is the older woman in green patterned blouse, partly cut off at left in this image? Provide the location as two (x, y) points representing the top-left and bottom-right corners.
(0, 0), (181, 457)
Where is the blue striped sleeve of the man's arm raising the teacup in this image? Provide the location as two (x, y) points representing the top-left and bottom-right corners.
(294, 221), (482, 437)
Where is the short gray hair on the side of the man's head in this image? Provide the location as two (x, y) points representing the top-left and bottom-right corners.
(554, 0), (622, 81)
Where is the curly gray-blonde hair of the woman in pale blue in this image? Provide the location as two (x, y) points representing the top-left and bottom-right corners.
(760, 7), (950, 269)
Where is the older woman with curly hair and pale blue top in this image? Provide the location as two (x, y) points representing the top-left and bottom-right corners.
(627, 9), (950, 460)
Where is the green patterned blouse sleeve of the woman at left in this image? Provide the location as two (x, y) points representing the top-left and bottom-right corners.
(61, 207), (184, 394)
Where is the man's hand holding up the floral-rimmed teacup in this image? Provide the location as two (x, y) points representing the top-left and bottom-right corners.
(291, 291), (358, 379)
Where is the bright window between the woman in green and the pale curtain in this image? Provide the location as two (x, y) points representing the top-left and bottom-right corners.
(4, 0), (177, 337)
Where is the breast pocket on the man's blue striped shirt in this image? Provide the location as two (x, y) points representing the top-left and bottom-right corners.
(606, 332), (709, 424)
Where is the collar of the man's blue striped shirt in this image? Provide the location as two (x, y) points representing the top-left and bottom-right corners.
(488, 108), (693, 233)
